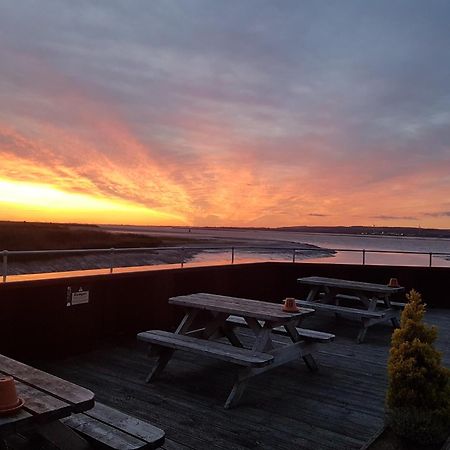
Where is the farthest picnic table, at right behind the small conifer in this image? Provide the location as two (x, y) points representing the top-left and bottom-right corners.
(297, 277), (404, 343)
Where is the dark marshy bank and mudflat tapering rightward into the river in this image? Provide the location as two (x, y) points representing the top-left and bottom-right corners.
(0, 222), (334, 275)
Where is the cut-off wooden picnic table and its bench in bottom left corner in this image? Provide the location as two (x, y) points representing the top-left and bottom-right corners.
(0, 355), (164, 450)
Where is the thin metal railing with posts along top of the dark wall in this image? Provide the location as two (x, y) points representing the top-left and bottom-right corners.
(1, 246), (450, 282)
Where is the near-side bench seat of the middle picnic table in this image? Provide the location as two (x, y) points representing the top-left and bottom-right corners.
(137, 330), (273, 367)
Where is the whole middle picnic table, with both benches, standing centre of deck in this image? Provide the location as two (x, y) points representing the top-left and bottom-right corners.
(138, 293), (334, 408)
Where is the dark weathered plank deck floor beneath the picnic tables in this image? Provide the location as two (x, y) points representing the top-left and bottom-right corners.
(38, 309), (450, 450)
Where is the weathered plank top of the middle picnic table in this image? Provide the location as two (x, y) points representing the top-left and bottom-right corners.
(169, 293), (314, 322)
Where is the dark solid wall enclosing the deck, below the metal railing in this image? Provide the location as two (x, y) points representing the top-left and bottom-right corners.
(0, 262), (450, 360)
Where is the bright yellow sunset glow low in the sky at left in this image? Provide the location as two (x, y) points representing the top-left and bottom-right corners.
(0, 179), (186, 225)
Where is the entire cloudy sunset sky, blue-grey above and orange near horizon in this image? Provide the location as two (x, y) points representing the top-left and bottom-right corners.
(0, 0), (450, 228)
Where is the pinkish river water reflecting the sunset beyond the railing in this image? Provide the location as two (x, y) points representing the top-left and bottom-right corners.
(106, 227), (450, 267)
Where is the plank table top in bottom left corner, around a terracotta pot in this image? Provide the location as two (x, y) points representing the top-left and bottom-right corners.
(0, 355), (94, 435)
